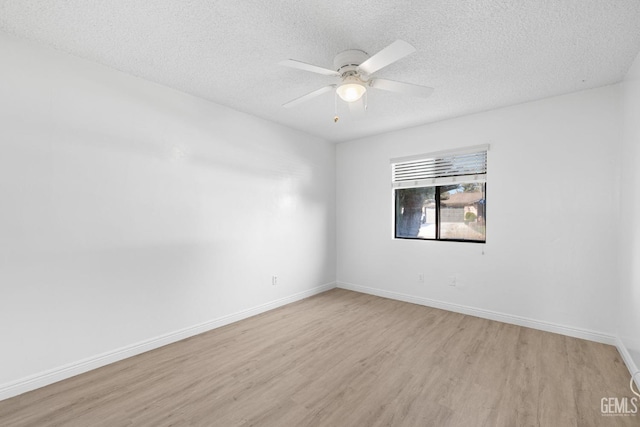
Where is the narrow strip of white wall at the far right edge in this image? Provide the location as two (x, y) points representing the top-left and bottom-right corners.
(618, 52), (640, 374)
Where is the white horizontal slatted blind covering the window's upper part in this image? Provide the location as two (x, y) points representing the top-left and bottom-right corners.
(391, 145), (489, 188)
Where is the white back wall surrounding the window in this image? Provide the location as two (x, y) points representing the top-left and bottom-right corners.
(337, 86), (621, 342)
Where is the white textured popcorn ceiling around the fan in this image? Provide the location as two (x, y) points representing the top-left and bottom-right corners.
(0, 0), (640, 141)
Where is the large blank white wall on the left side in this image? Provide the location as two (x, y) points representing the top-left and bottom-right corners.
(0, 35), (336, 397)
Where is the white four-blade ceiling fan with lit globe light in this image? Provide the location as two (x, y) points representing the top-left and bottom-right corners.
(279, 40), (433, 112)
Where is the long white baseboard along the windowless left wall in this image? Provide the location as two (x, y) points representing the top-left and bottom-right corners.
(0, 282), (336, 400)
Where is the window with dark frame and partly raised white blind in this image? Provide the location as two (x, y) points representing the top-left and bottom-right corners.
(391, 145), (489, 242)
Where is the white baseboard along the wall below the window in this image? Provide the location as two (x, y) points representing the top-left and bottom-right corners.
(337, 282), (616, 345)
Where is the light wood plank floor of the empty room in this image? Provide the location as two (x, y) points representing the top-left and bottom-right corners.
(0, 289), (640, 427)
